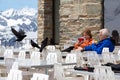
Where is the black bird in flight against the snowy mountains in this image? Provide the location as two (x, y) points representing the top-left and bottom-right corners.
(11, 27), (26, 42)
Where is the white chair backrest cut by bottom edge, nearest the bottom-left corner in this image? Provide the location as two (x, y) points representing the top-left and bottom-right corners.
(7, 69), (22, 80)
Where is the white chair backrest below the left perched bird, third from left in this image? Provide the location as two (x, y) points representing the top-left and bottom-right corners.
(30, 51), (41, 65)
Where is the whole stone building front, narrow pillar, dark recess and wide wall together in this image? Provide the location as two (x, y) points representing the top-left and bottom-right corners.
(38, 0), (103, 45)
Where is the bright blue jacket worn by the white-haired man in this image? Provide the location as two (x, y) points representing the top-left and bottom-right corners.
(84, 38), (115, 54)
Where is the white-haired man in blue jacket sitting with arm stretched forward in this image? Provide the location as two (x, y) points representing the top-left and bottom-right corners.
(78, 28), (115, 54)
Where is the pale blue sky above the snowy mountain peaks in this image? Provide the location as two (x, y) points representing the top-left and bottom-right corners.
(0, 0), (38, 11)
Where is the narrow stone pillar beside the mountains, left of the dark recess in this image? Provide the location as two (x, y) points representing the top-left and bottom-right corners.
(38, 0), (53, 43)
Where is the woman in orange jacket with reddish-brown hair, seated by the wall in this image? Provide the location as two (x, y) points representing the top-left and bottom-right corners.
(74, 29), (94, 49)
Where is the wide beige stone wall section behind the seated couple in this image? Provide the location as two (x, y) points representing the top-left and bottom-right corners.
(60, 0), (102, 45)
